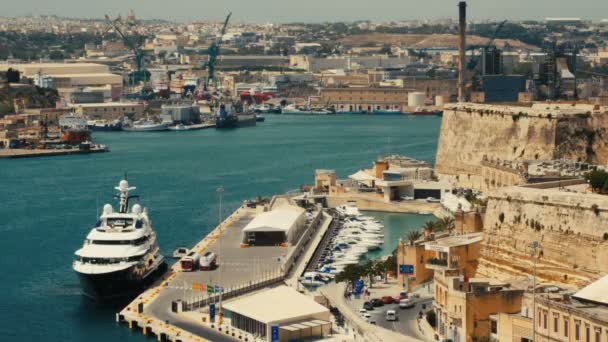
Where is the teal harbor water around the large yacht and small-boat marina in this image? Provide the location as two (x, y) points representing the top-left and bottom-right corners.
(0, 115), (441, 341)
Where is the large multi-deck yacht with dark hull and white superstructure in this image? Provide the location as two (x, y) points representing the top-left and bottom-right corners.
(72, 180), (167, 301)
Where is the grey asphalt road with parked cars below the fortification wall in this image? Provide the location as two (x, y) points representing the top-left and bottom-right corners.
(360, 298), (433, 341)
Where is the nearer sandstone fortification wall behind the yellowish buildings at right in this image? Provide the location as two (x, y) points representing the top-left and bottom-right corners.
(478, 187), (608, 286)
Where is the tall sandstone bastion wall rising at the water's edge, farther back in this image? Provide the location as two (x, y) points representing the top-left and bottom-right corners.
(435, 103), (608, 190)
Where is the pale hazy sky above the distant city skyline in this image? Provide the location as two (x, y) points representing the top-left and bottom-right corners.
(0, 0), (608, 22)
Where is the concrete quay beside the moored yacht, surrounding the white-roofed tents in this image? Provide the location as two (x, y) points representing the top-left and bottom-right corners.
(116, 198), (332, 341)
